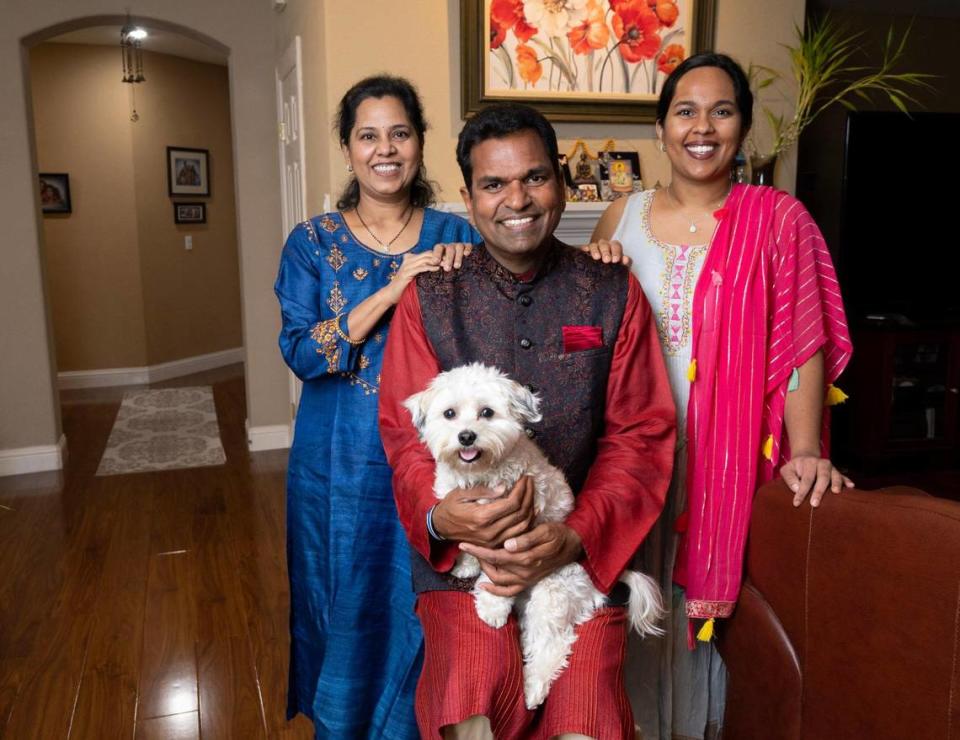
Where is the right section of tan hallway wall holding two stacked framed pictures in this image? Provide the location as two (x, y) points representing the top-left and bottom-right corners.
(132, 49), (243, 365)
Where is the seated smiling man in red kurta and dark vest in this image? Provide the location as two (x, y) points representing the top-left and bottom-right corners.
(380, 104), (675, 740)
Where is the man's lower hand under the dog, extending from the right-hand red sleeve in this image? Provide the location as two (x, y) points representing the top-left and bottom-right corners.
(460, 522), (583, 596)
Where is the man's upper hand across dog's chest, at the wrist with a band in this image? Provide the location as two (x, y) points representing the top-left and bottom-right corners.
(433, 476), (534, 547)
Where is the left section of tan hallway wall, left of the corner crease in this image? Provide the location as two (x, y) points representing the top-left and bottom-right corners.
(30, 44), (147, 370)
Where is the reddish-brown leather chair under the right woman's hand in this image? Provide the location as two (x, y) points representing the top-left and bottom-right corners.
(719, 481), (960, 740)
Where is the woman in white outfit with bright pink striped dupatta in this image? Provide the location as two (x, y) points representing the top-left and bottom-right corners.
(593, 54), (853, 740)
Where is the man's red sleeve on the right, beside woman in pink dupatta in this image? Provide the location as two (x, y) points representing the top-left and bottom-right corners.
(567, 275), (676, 593)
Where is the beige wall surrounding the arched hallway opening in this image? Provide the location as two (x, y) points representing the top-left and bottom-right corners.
(0, 0), (290, 450)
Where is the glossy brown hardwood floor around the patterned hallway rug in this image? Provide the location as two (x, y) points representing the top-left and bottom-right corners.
(0, 366), (312, 740)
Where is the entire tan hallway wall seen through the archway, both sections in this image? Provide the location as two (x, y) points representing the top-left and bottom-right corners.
(30, 44), (242, 371)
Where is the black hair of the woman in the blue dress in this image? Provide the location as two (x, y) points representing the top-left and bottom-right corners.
(333, 75), (437, 211)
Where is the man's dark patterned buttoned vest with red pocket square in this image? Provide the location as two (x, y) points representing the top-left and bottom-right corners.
(413, 242), (629, 593)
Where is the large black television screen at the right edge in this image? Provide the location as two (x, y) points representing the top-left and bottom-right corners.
(836, 112), (960, 325)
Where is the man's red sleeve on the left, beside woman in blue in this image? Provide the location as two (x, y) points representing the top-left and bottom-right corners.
(380, 282), (458, 571)
